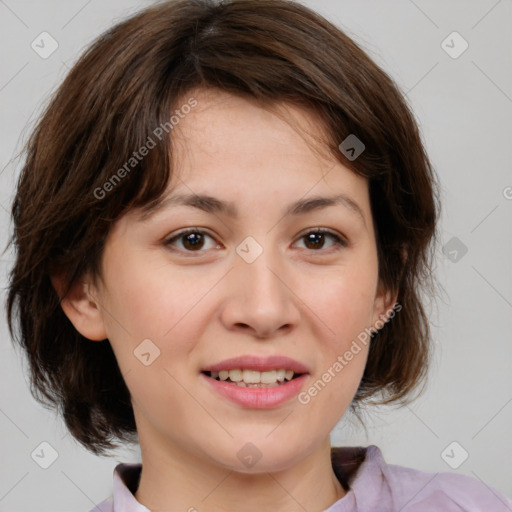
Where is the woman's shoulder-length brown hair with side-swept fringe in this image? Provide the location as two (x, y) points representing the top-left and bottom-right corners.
(7, 0), (438, 454)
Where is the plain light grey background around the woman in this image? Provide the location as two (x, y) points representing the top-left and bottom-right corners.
(0, 0), (512, 512)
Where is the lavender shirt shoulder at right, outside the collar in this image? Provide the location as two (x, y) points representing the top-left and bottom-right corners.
(379, 446), (512, 512)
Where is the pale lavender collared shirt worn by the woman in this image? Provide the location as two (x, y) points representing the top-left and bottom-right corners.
(90, 445), (512, 512)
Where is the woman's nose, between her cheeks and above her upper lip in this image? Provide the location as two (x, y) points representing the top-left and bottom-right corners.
(221, 244), (300, 338)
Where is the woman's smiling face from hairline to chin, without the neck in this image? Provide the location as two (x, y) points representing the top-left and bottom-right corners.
(86, 91), (394, 472)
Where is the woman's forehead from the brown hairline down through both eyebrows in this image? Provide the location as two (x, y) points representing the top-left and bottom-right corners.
(123, 90), (371, 230)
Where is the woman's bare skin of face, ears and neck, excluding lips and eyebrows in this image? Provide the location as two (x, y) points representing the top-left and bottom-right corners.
(54, 90), (396, 512)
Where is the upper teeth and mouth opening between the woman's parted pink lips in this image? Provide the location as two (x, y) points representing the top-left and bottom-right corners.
(202, 368), (304, 388)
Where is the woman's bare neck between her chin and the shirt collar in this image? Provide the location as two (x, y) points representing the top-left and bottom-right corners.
(135, 438), (346, 512)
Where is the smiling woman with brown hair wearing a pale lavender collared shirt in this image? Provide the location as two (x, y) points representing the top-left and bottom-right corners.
(8, 0), (510, 512)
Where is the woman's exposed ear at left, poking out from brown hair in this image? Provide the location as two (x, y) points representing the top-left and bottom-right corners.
(51, 275), (107, 341)
